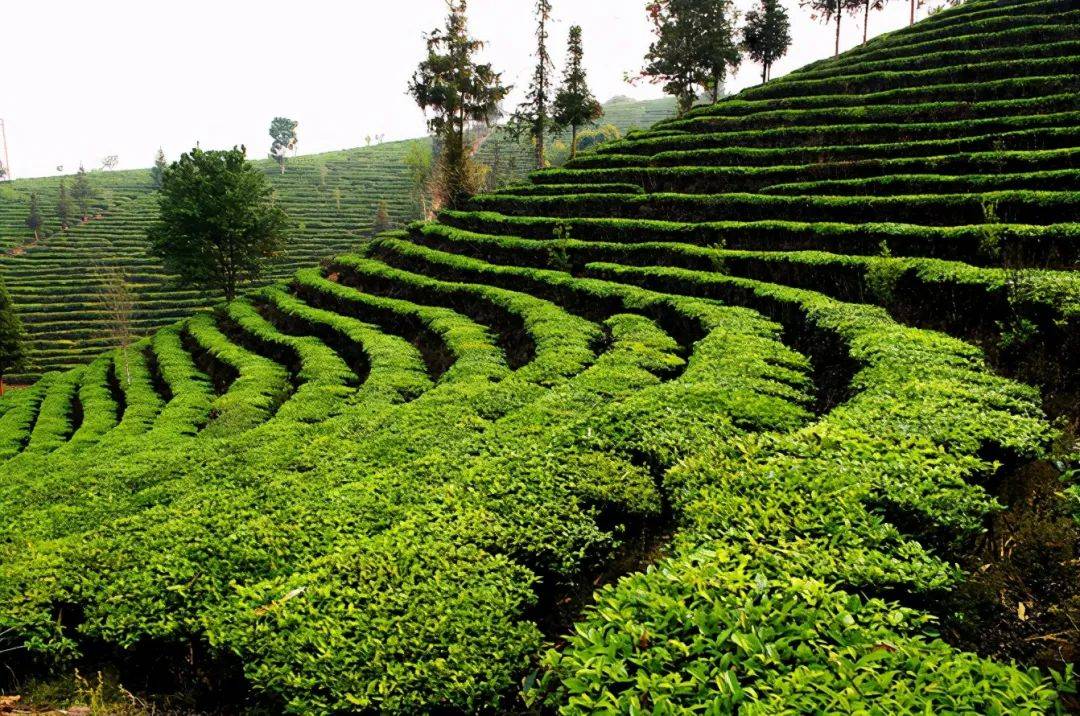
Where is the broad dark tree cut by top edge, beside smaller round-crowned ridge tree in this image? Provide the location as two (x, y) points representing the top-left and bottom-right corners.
(642, 0), (742, 113)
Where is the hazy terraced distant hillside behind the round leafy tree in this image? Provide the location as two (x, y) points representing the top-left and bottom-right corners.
(0, 98), (675, 386)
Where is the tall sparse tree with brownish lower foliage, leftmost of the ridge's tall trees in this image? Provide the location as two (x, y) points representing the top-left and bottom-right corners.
(408, 0), (510, 208)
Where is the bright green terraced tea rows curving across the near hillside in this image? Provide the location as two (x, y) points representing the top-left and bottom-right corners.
(0, 0), (1080, 714)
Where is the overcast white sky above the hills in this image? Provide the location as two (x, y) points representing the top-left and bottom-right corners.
(0, 0), (926, 177)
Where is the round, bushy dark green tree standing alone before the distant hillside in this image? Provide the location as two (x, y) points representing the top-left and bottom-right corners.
(148, 147), (286, 301)
